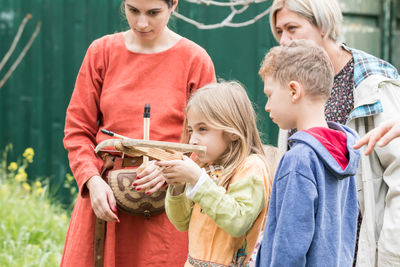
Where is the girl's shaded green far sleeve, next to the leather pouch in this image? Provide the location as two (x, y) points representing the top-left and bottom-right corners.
(165, 186), (193, 232)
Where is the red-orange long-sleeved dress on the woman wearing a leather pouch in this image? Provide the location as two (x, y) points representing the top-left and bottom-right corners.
(61, 33), (215, 267)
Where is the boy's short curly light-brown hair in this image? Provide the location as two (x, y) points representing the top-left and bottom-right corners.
(259, 40), (334, 100)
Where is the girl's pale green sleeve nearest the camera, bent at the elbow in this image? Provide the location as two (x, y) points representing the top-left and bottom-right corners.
(193, 176), (266, 237)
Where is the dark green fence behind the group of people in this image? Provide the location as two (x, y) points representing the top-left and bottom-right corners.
(0, 0), (400, 201)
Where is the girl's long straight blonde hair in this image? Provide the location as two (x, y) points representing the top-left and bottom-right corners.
(182, 81), (265, 187)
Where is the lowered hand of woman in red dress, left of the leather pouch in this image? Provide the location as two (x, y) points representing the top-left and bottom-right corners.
(86, 175), (119, 222)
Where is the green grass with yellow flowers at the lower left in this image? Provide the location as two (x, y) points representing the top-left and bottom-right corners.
(0, 145), (68, 267)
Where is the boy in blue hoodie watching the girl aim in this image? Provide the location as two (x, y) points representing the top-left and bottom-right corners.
(256, 40), (360, 267)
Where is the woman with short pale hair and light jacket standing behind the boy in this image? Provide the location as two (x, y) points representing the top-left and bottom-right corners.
(256, 0), (400, 266)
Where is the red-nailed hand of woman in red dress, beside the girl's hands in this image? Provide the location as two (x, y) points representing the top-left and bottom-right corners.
(133, 161), (165, 194)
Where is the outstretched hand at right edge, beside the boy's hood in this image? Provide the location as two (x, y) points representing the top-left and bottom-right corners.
(353, 118), (400, 155)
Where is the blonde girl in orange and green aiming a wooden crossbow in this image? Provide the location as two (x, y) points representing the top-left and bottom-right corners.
(157, 82), (271, 266)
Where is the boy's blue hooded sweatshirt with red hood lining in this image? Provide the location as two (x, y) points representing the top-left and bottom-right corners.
(256, 122), (360, 267)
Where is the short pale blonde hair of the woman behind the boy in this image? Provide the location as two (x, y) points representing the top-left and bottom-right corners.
(269, 0), (343, 41)
